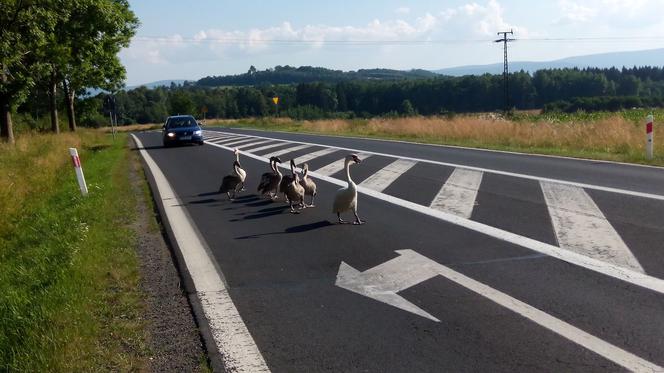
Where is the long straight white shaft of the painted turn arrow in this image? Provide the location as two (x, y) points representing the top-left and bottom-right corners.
(429, 251), (664, 372)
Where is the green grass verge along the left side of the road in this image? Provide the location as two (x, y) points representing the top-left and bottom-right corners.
(0, 130), (147, 372)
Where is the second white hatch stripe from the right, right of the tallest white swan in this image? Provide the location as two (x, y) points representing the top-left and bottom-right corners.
(430, 168), (483, 219)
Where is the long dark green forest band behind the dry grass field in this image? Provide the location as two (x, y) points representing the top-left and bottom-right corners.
(55, 67), (664, 126)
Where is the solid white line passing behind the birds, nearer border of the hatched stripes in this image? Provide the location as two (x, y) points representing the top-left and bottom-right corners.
(205, 140), (664, 294)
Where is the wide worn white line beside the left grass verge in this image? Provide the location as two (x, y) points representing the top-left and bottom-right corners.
(132, 135), (270, 372)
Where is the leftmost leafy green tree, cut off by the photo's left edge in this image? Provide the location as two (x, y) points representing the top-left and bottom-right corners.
(0, 0), (60, 143)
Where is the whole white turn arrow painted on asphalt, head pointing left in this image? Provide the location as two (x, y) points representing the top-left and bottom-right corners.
(335, 250), (664, 372)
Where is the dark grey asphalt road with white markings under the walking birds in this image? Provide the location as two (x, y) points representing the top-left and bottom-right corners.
(137, 129), (664, 372)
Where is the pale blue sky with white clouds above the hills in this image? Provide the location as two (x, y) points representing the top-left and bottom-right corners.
(120, 0), (664, 86)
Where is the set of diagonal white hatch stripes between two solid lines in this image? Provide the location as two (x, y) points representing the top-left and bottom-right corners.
(205, 131), (660, 273)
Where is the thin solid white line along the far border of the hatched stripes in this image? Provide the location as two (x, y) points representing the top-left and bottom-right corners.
(206, 131), (664, 201)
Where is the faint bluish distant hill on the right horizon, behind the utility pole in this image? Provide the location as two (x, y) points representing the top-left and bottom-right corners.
(434, 49), (664, 76)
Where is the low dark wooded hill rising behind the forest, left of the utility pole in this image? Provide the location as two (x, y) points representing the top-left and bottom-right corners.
(196, 66), (437, 87)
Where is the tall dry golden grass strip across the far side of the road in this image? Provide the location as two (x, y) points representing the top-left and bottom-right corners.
(208, 110), (664, 166)
